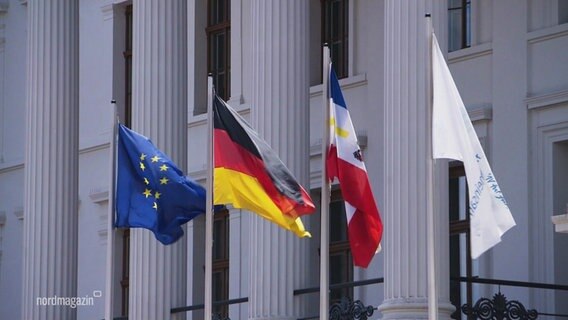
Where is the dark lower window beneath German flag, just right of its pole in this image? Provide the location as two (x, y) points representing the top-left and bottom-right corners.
(212, 210), (229, 319)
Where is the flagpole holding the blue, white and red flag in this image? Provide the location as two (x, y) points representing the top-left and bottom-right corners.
(320, 45), (330, 320)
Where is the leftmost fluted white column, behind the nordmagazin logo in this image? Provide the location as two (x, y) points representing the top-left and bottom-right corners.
(22, 0), (79, 320)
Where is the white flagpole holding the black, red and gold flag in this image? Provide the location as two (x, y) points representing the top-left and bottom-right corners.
(205, 74), (214, 320)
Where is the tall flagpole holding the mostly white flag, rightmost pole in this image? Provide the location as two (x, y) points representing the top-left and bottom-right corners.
(425, 13), (438, 319)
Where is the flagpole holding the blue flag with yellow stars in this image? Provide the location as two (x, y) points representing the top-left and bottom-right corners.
(105, 99), (118, 320)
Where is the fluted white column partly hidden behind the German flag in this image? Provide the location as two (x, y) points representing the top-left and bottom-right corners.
(249, 0), (309, 319)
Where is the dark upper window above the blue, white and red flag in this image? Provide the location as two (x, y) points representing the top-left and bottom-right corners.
(322, 0), (349, 79)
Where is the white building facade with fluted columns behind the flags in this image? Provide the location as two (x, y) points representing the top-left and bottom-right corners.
(0, 0), (568, 320)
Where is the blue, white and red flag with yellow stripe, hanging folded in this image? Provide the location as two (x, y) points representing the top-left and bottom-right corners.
(327, 66), (383, 268)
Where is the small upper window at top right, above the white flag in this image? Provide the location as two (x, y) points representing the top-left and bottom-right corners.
(448, 0), (471, 52)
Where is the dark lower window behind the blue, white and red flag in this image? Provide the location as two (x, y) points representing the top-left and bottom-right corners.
(329, 191), (353, 304)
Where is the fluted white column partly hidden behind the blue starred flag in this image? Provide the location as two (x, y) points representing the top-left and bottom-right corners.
(128, 0), (187, 319)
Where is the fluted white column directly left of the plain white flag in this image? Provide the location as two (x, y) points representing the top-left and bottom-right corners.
(379, 0), (453, 319)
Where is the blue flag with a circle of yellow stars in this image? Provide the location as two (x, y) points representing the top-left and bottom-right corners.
(116, 124), (205, 244)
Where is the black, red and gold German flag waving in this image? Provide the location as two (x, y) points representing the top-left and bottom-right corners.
(213, 96), (315, 237)
